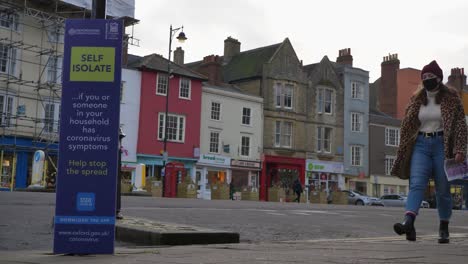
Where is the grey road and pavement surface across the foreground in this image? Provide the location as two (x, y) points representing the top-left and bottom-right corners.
(0, 192), (468, 264)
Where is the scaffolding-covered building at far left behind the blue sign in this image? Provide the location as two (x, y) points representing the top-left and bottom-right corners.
(0, 0), (139, 190)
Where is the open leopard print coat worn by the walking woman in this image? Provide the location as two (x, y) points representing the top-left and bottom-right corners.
(391, 87), (467, 179)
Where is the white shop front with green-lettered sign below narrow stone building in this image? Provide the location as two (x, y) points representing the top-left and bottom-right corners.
(306, 159), (346, 192)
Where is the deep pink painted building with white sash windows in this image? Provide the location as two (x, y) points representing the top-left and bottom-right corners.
(129, 54), (206, 184)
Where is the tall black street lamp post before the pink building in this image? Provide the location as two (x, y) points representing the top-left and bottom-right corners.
(163, 25), (187, 196)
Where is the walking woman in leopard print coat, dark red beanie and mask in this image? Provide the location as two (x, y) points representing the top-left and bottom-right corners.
(391, 61), (467, 243)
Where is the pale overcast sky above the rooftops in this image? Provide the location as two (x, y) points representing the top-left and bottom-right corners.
(130, 0), (468, 81)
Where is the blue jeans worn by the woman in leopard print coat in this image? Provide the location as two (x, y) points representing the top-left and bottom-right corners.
(406, 135), (452, 221)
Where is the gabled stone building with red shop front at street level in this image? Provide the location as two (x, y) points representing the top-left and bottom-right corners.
(187, 37), (308, 201)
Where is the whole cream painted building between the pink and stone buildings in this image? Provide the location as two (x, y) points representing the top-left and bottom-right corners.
(196, 83), (263, 199)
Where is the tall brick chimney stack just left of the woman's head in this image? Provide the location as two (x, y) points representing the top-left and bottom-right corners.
(379, 54), (400, 118)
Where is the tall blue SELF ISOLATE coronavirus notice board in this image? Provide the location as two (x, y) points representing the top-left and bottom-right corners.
(53, 19), (123, 254)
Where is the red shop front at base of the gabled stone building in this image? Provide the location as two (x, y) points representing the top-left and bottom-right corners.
(260, 155), (305, 201)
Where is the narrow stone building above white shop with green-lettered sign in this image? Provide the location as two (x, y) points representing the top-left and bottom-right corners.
(304, 56), (346, 192)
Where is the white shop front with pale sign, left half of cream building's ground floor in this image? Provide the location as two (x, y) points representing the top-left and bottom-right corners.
(195, 154), (231, 200)
